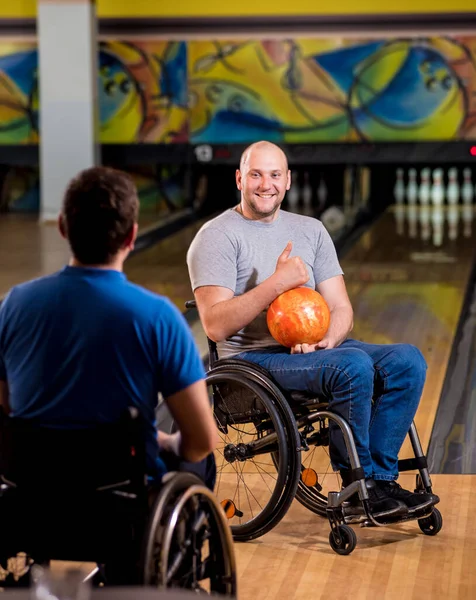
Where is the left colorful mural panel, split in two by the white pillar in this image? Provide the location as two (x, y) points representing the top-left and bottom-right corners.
(0, 42), (188, 144)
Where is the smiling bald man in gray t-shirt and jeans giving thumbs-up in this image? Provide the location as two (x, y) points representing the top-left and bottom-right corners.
(187, 142), (439, 518)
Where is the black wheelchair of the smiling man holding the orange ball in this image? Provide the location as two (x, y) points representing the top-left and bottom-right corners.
(185, 300), (442, 554)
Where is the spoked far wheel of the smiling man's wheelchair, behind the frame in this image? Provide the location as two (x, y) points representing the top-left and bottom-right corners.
(296, 423), (342, 517)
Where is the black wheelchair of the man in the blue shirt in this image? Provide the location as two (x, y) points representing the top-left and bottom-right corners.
(0, 409), (236, 597)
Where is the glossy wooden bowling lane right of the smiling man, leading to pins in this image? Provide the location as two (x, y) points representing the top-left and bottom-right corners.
(341, 206), (476, 449)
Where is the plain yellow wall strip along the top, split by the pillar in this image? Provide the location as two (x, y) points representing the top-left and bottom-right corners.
(0, 0), (476, 18)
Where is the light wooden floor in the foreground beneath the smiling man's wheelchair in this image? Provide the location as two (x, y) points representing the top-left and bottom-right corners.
(235, 475), (476, 600)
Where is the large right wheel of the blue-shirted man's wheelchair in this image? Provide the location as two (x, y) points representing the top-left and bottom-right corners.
(142, 473), (236, 597)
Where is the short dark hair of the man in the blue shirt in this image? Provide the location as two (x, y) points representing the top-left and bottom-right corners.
(62, 167), (139, 265)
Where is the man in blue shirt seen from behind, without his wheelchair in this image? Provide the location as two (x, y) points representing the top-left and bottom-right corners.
(0, 167), (217, 487)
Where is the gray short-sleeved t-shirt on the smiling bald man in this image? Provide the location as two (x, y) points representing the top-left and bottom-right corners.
(187, 209), (343, 358)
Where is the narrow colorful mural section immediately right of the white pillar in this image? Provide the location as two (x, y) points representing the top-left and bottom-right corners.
(99, 42), (188, 144)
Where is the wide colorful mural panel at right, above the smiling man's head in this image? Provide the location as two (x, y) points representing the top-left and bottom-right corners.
(188, 37), (476, 143)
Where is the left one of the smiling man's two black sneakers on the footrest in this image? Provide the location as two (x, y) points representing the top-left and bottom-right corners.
(342, 479), (408, 523)
